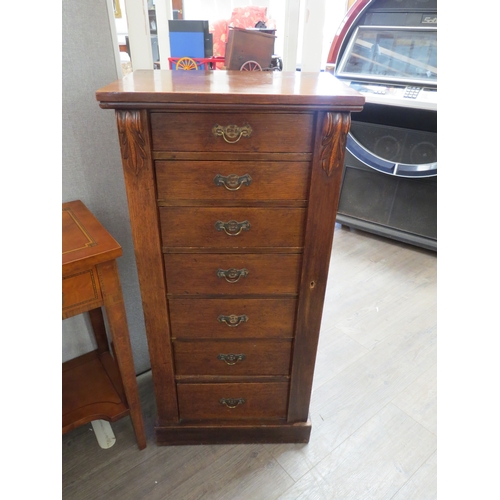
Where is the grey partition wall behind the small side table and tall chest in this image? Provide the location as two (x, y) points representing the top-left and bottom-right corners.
(61, 0), (150, 373)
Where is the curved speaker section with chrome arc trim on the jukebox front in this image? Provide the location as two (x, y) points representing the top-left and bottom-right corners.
(346, 120), (437, 177)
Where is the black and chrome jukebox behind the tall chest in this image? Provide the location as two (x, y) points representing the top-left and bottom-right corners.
(328, 0), (437, 251)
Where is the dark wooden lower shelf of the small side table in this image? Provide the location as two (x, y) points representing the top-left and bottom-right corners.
(62, 350), (130, 434)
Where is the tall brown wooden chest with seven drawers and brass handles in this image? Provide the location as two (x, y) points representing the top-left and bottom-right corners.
(97, 70), (364, 444)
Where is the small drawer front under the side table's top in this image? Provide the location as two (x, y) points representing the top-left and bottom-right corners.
(62, 268), (101, 313)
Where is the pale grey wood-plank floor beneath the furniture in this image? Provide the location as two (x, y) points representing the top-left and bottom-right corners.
(62, 226), (437, 500)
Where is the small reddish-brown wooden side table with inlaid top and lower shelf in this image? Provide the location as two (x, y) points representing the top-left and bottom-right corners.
(62, 200), (146, 450)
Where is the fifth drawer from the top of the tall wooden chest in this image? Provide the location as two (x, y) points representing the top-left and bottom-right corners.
(169, 299), (297, 339)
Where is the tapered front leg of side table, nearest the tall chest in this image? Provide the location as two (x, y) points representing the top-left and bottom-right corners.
(97, 260), (146, 450)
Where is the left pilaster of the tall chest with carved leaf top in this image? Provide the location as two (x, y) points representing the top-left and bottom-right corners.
(116, 110), (179, 422)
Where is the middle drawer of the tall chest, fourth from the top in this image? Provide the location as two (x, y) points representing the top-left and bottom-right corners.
(164, 254), (302, 295)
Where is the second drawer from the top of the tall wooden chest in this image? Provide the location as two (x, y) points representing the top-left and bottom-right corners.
(155, 161), (310, 201)
